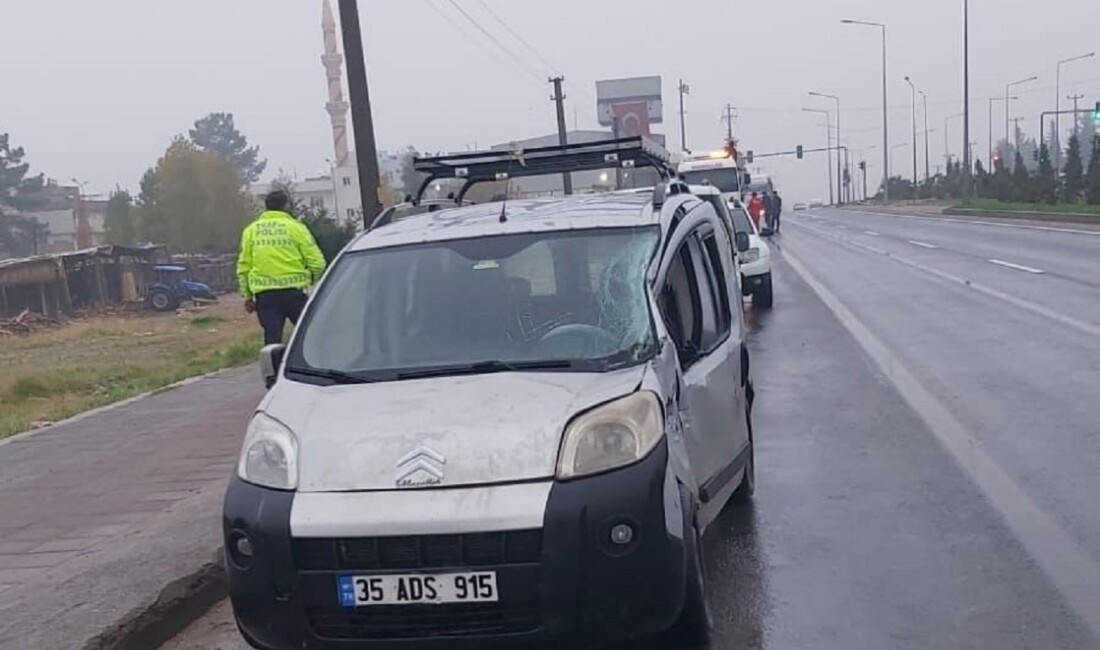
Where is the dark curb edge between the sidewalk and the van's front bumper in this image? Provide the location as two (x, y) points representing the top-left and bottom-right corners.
(80, 548), (229, 650)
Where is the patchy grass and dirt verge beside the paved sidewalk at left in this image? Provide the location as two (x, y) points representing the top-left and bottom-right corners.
(0, 296), (261, 438)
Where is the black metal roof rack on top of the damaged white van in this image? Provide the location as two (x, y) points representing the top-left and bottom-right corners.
(413, 136), (675, 203)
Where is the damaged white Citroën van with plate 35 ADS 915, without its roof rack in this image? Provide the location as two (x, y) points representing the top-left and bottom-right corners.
(223, 186), (755, 650)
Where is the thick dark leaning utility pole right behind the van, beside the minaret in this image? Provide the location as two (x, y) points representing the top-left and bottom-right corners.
(340, 0), (382, 229)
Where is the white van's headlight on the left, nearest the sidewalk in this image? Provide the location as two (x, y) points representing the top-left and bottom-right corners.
(237, 414), (298, 489)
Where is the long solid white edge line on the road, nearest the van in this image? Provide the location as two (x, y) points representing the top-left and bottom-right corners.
(784, 245), (1100, 639)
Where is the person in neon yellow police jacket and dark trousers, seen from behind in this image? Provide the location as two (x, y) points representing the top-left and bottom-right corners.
(237, 190), (325, 345)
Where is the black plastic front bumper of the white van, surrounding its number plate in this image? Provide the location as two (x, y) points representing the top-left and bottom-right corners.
(223, 443), (685, 650)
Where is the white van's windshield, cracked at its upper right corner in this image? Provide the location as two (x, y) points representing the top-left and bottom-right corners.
(287, 228), (659, 381)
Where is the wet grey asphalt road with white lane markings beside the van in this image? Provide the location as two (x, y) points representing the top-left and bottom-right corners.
(162, 210), (1100, 650)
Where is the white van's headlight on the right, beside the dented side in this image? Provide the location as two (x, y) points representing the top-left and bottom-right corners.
(558, 390), (664, 480)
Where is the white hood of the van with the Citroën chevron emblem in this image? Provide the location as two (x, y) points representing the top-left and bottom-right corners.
(262, 365), (646, 492)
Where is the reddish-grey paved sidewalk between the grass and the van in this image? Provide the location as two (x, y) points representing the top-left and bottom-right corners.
(0, 367), (263, 650)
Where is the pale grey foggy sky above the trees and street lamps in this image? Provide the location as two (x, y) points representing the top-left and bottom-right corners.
(0, 0), (1100, 200)
